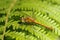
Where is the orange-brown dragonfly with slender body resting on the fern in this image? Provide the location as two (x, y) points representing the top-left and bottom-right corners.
(21, 17), (53, 30)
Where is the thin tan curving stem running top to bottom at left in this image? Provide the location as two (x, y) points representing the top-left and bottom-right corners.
(2, 0), (17, 40)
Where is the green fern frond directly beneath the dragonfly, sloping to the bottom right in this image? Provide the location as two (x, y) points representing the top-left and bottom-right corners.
(6, 21), (57, 40)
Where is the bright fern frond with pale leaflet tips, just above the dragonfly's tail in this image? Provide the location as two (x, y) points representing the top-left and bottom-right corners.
(35, 13), (60, 35)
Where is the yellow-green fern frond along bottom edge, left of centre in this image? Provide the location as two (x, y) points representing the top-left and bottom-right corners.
(5, 31), (37, 40)
